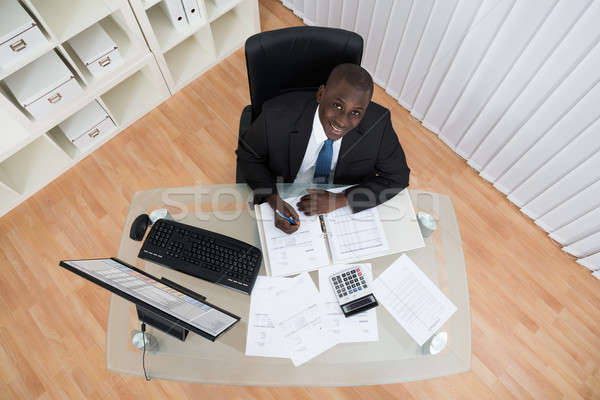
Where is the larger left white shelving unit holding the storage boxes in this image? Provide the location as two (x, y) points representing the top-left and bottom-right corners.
(0, 0), (170, 215)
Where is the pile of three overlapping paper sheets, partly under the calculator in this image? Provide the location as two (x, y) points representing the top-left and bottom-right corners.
(246, 264), (379, 366)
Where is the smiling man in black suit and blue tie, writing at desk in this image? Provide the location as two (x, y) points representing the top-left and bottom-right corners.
(237, 64), (410, 233)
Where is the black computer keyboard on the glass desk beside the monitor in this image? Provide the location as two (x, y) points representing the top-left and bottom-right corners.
(138, 219), (262, 294)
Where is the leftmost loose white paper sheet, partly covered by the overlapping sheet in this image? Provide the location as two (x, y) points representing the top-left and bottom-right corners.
(246, 276), (293, 358)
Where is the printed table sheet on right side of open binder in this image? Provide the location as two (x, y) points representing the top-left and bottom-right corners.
(324, 206), (389, 262)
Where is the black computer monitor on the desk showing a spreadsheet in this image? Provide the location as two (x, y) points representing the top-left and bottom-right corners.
(59, 258), (240, 341)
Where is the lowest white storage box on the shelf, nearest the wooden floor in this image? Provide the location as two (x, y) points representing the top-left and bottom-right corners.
(58, 101), (115, 151)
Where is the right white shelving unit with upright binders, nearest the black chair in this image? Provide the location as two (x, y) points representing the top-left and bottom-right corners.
(130, 0), (260, 94)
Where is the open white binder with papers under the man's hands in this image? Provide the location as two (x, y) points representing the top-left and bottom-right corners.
(254, 188), (425, 276)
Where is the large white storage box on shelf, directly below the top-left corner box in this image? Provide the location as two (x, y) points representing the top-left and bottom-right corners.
(4, 51), (83, 119)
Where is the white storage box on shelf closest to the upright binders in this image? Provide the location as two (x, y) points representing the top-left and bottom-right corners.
(69, 24), (123, 77)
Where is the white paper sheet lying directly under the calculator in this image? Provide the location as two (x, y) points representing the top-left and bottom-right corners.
(319, 264), (379, 343)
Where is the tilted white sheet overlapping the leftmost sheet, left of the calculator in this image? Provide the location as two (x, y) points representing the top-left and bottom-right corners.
(273, 272), (336, 366)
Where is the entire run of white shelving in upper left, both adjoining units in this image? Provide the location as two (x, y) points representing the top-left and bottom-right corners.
(0, 0), (260, 216)
